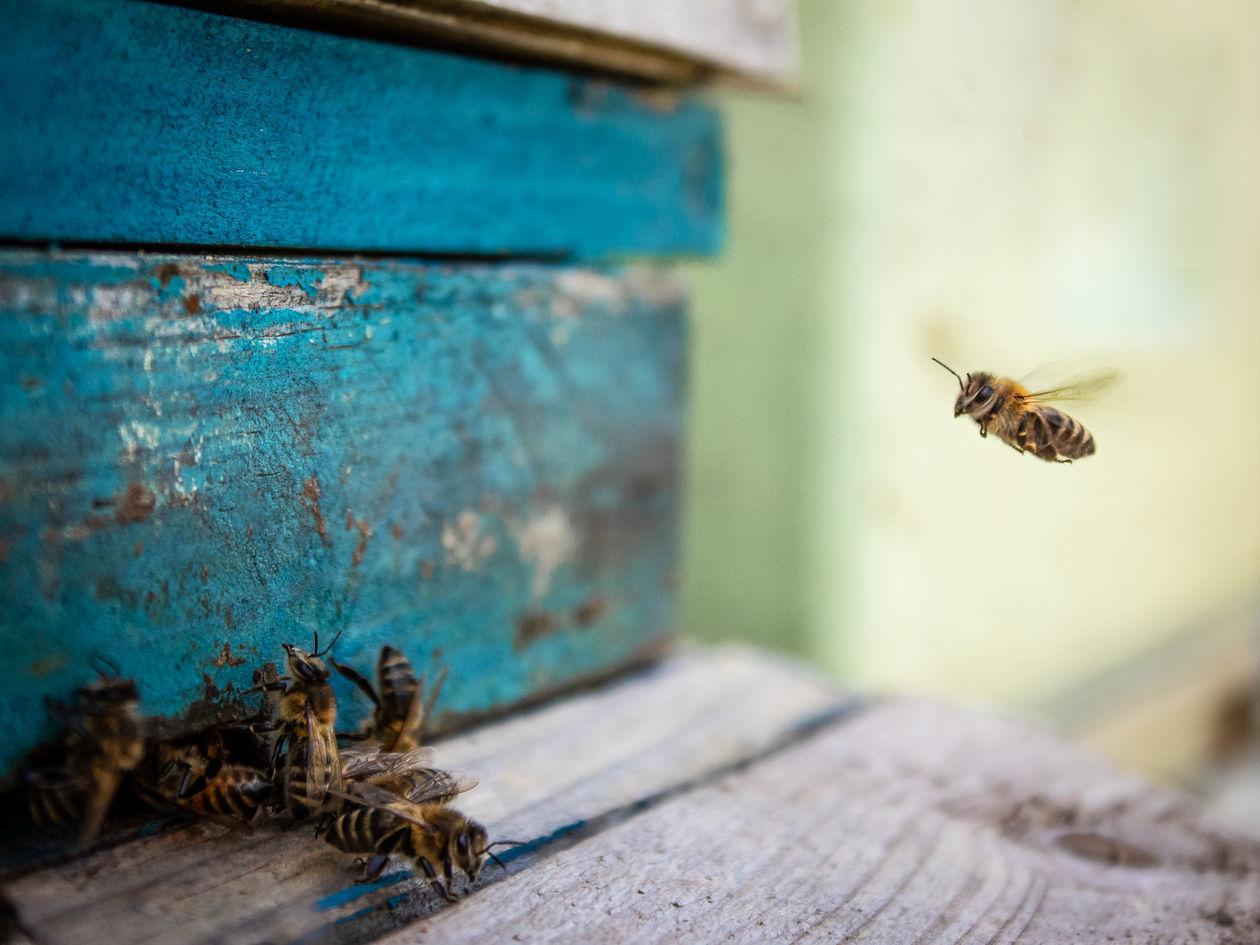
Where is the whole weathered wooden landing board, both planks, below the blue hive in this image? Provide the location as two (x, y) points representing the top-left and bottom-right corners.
(9, 650), (1260, 945)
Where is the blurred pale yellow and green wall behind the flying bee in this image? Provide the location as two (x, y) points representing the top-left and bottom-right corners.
(684, 0), (1260, 756)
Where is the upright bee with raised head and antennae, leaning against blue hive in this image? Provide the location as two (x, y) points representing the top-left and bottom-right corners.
(255, 631), (341, 820)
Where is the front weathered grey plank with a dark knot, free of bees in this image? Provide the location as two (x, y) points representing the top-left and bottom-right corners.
(386, 702), (1260, 945)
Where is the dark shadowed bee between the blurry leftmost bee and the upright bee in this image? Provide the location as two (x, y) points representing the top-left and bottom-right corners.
(132, 728), (272, 830)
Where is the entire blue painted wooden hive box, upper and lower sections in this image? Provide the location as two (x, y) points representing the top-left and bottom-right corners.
(0, 0), (721, 771)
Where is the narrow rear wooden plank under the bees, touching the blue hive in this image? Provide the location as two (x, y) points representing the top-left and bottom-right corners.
(0, 650), (852, 945)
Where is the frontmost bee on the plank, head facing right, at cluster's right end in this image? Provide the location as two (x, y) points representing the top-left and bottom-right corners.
(321, 777), (515, 902)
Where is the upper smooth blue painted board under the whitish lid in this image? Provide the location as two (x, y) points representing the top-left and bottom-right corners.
(0, 0), (721, 258)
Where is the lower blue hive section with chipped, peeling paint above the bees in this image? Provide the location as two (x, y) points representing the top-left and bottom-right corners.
(0, 251), (684, 770)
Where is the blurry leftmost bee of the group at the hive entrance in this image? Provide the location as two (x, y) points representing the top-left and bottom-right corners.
(26, 675), (145, 845)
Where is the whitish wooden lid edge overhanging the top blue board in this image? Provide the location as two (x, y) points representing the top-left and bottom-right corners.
(184, 0), (798, 86)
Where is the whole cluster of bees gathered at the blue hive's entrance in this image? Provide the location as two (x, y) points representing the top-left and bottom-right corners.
(23, 638), (514, 901)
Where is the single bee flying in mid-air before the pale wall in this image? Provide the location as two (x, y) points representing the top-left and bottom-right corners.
(932, 358), (1119, 462)
